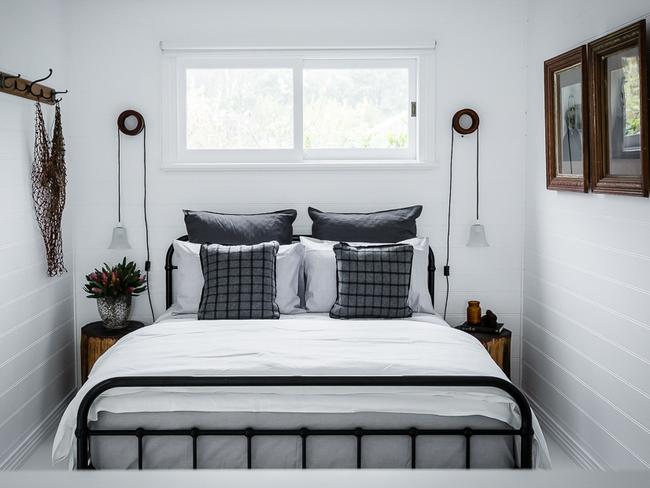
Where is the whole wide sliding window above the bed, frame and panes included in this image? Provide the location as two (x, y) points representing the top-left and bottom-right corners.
(163, 47), (433, 167)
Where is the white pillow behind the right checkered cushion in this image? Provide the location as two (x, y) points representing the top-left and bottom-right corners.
(300, 236), (433, 313)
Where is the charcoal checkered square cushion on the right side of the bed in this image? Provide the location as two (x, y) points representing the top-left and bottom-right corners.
(330, 242), (413, 319)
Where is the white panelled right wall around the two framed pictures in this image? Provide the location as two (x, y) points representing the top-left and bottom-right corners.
(522, 0), (650, 468)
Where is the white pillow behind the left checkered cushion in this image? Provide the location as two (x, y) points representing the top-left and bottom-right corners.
(174, 241), (304, 314)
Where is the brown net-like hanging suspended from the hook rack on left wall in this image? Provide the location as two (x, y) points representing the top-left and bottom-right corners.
(32, 103), (67, 276)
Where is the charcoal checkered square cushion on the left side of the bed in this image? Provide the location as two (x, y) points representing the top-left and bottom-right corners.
(198, 241), (280, 320)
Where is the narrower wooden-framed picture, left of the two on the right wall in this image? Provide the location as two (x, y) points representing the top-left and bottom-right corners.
(544, 46), (589, 192)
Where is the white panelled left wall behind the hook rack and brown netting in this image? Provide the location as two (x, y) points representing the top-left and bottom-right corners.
(0, 0), (75, 468)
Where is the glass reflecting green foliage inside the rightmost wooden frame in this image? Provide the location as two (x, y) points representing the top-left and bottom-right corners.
(605, 46), (641, 176)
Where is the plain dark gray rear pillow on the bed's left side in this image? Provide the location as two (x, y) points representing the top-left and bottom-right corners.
(183, 209), (297, 246)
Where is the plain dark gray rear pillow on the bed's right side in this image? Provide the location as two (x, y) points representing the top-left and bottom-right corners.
(308, 205), (422, 242)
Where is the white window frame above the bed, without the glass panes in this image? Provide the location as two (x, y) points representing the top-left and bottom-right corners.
(161, 43), (435, 170)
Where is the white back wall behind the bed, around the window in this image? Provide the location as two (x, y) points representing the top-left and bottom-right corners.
(66, 0), (526, 386)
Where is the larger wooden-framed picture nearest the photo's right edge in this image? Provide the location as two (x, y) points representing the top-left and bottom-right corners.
(588, 20), (650, 197)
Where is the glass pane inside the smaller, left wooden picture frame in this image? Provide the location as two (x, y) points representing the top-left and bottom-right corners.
(555, 64), (584, 176)
